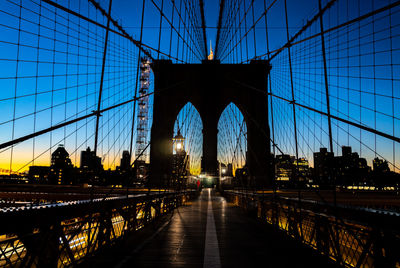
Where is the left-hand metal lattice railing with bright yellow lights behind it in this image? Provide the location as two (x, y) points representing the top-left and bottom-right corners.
(0, 190), (197, 267)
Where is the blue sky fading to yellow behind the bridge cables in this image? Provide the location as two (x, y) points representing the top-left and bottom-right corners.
(0, 0), (400, 174)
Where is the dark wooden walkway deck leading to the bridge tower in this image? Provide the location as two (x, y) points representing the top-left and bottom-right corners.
(96, 189), (334, 267)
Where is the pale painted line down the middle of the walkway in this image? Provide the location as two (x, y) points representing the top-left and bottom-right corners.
(203, 189), (221, 268)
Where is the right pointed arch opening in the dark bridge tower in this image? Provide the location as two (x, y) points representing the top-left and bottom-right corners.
(217, 102), (247, 180)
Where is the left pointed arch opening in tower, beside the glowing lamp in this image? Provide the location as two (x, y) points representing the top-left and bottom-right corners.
(173, 102), (203, 176)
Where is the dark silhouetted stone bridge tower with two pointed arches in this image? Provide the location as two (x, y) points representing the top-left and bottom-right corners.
(149, 60), (273, 187)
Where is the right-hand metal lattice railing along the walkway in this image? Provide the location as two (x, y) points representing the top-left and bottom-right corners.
(224, 191), (400, 267)
